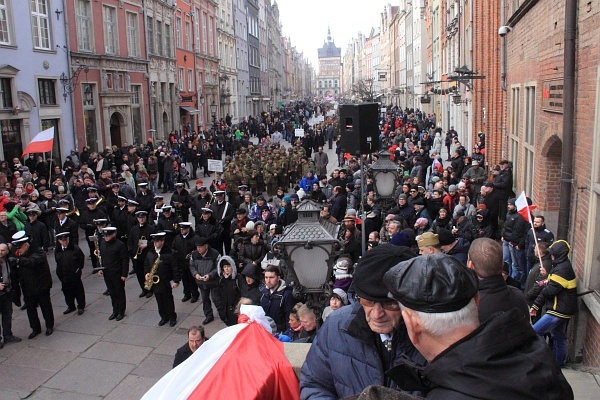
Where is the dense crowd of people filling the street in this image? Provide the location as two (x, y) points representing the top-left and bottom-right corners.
(0, 103), (576, 398)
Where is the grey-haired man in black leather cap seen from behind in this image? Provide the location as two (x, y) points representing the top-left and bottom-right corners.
(383, 254), (573, 400)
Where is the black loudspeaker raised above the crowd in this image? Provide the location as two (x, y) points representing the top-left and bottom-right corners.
(340, 103), (379, 154)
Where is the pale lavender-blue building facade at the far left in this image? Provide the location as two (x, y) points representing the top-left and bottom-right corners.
(0, 0), (75, 165)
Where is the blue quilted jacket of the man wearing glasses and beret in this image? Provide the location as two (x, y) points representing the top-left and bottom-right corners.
(300, 302), (426, 400)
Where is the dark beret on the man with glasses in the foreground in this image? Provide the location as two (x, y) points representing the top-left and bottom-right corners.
(354, 244), (416, 301)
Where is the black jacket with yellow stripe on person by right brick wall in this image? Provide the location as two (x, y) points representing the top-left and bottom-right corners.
(532, 240), (577, 318)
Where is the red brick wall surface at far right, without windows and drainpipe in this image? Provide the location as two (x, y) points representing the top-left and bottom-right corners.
(506, 0), (600, 367)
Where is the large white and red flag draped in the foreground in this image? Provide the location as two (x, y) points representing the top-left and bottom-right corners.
(142, 305), (300, 400)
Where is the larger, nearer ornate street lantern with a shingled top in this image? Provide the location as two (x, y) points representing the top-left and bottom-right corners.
(274, 200), (342, 307)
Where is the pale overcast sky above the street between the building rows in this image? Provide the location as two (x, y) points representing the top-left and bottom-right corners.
(276, 0), (399, 69)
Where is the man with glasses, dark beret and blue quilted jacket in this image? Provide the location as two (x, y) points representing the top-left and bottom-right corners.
(300, 244), (425, 399)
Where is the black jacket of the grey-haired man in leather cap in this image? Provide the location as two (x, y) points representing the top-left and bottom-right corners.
(386, 309), (573, 400)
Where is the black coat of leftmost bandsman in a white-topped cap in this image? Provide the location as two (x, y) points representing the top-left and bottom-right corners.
(18, 246), (52, 296)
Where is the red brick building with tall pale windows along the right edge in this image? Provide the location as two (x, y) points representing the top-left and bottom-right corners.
(506, 0), (600, 367)
